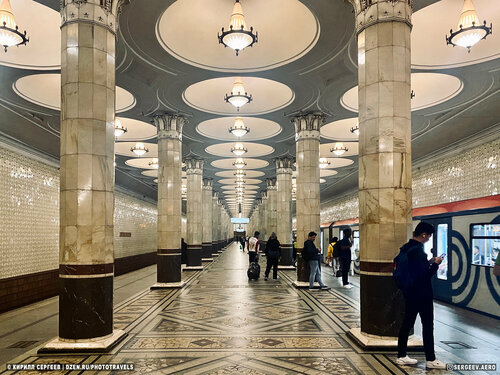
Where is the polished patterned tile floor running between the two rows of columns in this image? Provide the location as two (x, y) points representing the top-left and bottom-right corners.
(0, 242), (500, 375)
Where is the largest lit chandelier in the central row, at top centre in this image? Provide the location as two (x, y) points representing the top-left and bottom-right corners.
(217, 0), (258, 56)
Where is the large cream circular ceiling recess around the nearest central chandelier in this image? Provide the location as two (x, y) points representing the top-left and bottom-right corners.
(156, 0), (319, 72)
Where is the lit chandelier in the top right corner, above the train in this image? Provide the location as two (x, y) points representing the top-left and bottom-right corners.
(446, 0), (492, 53)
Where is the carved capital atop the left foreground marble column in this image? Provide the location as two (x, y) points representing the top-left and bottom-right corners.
(60, 0), (128, 34)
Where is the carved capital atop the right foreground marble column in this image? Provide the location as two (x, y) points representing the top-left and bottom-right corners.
(349, 0), (413, 34)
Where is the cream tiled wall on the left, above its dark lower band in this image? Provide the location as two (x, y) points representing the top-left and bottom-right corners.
(0, 146), (157, 278)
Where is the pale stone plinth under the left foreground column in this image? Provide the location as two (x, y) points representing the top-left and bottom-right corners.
(38, 330), (128, 354)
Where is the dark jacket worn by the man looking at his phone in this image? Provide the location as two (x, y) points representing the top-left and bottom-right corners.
(400, 239), (439, 299)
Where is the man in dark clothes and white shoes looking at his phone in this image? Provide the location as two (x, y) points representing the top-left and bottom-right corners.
(393, 221), (446, 369)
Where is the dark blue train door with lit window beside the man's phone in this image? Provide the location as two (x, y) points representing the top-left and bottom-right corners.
(424, 217), (452, 302)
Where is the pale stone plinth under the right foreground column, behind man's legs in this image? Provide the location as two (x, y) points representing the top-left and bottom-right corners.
(347, 328), (424, 351)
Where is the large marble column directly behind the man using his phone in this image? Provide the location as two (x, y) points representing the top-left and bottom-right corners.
(351, 0), (412, 347)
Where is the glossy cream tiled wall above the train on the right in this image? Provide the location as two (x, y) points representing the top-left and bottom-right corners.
(321, 139), (500, 223)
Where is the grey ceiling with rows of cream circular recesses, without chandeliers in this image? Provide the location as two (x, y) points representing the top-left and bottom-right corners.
(0, 0), (500, 215)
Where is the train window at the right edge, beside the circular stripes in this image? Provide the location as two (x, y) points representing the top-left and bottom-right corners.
(471, 224), (500, 267)
